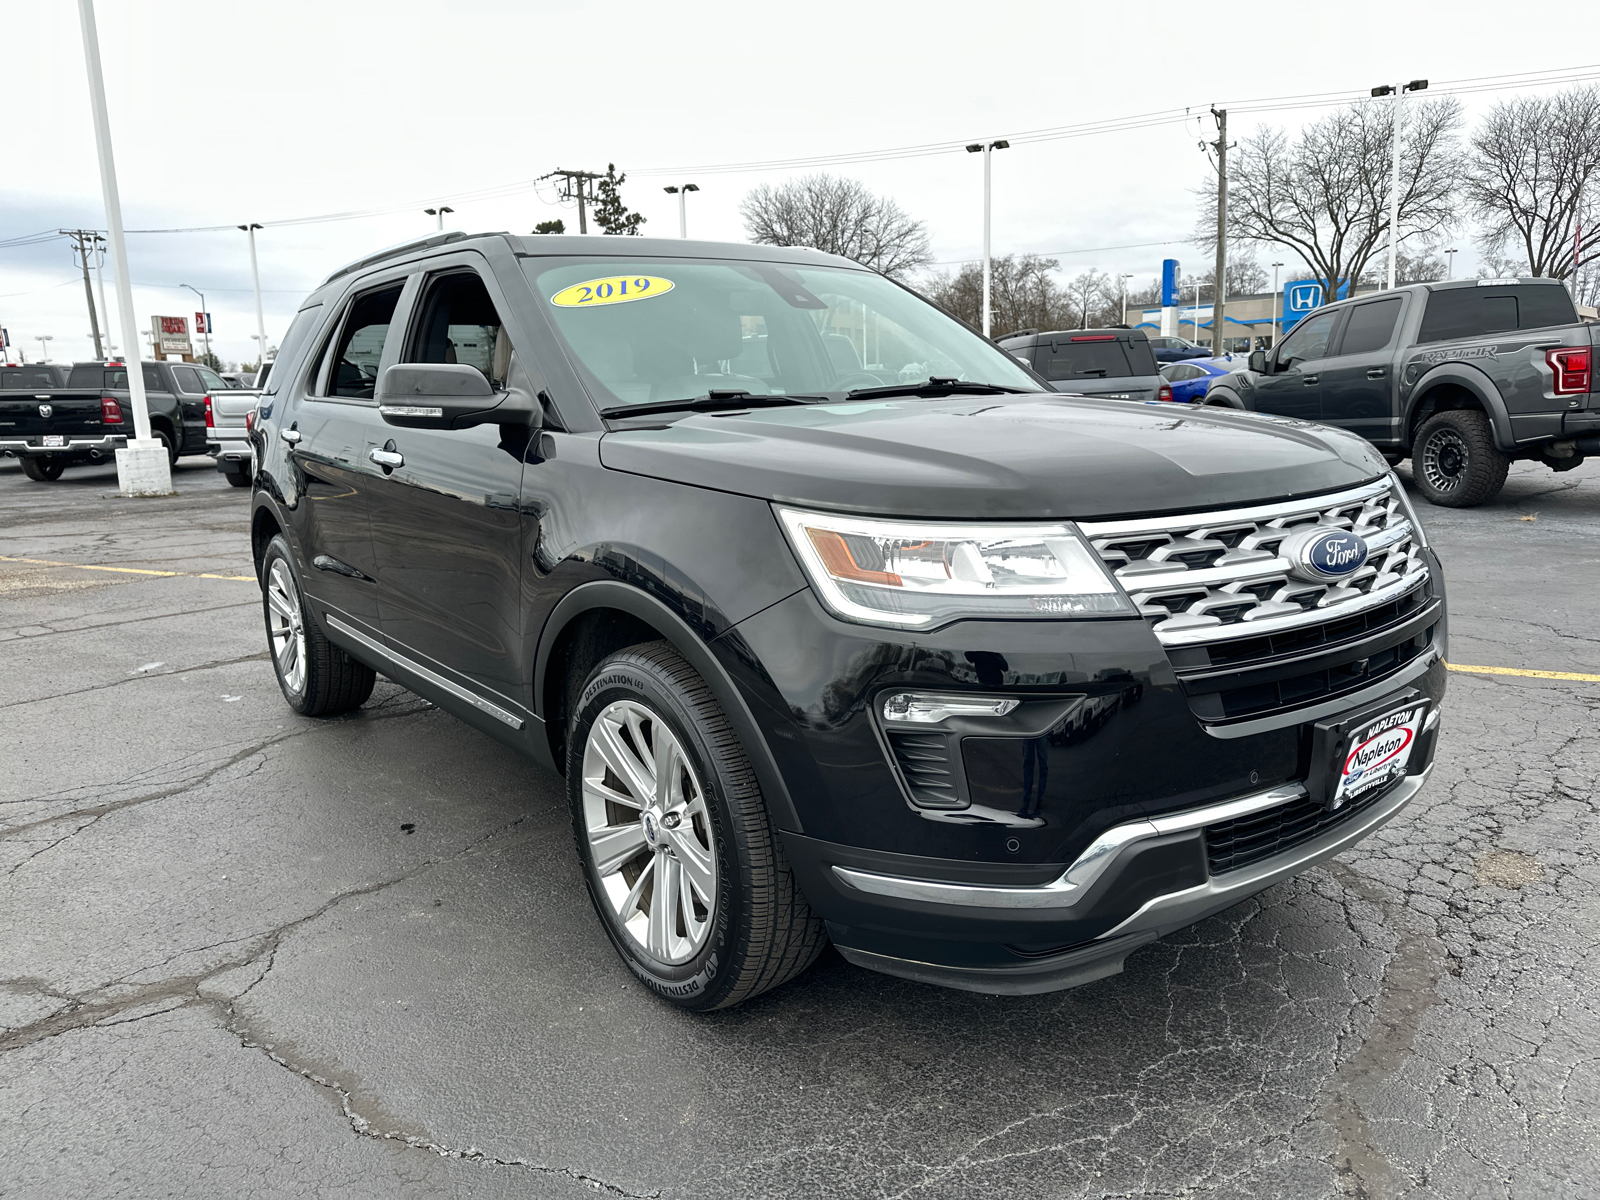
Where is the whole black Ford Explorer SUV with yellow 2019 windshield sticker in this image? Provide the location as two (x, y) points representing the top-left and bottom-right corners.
(251, 234), (1445, 1008)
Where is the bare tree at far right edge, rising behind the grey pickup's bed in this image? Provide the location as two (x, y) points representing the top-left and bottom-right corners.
(1464, 85), (1600, 278)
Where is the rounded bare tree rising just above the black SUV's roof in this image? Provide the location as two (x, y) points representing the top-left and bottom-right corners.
(739, 173), (933, 278)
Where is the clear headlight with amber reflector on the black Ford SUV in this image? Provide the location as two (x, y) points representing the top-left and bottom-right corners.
(778, 509), (1136, 629)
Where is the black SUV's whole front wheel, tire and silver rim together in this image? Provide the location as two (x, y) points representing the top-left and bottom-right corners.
(566, 642), (827, 1011)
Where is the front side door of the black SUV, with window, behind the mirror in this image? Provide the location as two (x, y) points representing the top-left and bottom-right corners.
(371, 256), (528, 706)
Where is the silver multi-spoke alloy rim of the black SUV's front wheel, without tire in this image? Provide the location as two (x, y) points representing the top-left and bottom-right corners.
(582, 699), (717, 966)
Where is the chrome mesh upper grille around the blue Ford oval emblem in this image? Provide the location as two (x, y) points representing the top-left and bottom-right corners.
(1080, 477), (1427, 646)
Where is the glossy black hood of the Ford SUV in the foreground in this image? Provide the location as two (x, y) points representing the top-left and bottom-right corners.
(600, 395), (1389, 520)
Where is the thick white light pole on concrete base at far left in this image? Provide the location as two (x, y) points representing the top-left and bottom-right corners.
(78, 0), (173, 496)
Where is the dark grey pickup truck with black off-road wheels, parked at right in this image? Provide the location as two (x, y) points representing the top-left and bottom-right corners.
(1205, 278), (1600, 509)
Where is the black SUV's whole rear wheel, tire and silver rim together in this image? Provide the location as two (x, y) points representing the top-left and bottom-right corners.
(261, 533), (378, 717)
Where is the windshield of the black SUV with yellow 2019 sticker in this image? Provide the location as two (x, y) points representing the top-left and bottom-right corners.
(523, 258), (1040, 408)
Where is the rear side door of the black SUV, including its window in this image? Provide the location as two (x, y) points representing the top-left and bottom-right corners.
(289, 272), (406, 632)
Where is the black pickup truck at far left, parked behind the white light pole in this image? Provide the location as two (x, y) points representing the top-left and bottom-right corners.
(0, 362), (210, 483)
